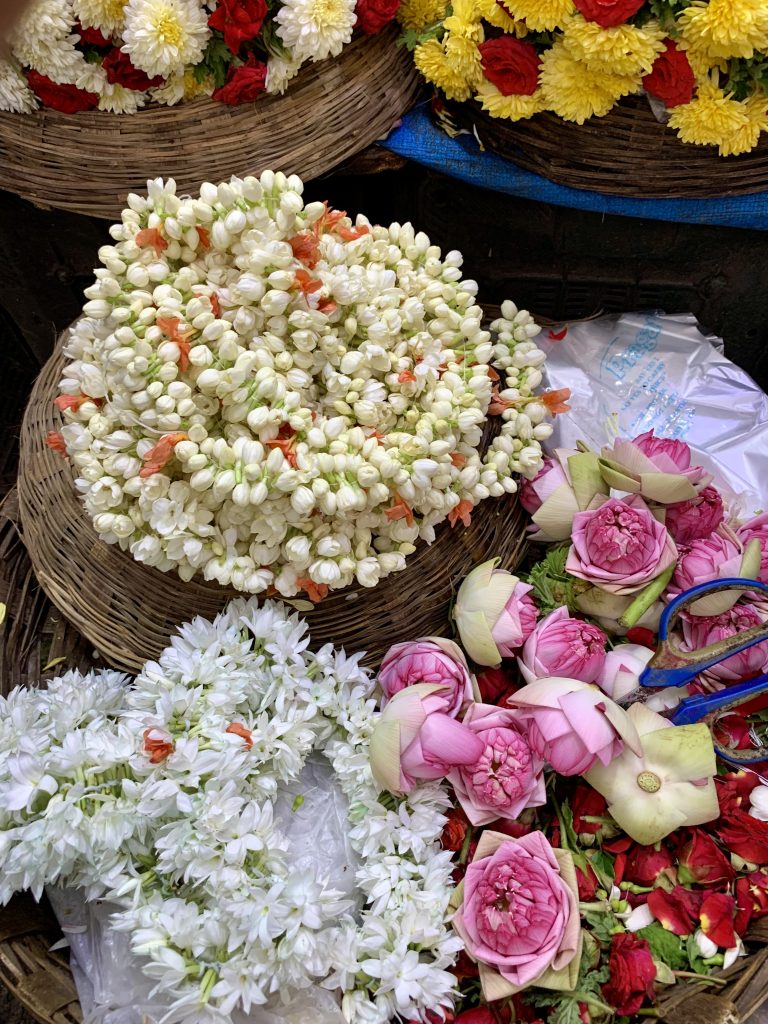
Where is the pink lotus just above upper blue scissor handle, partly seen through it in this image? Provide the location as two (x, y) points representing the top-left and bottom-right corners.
(667, 523), (760, 615)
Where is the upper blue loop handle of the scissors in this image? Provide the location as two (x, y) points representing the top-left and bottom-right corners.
(640, 579), (768, 692)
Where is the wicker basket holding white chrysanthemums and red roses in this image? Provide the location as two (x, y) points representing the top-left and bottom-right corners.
(0, 28), (420, 220)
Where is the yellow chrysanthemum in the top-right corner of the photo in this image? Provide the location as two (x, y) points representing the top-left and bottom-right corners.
(678, 0), (768, 59)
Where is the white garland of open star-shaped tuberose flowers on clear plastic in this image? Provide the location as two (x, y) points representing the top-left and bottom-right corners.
(0, 600), (461, 1024)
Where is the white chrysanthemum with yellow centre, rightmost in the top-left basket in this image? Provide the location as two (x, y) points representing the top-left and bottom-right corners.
(275, 0), (357, 61)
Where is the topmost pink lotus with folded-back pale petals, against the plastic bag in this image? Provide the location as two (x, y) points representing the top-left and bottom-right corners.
(600, 430), (712, 505)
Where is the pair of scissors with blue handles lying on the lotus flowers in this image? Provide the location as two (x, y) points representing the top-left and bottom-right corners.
(630, 579), (768, 765)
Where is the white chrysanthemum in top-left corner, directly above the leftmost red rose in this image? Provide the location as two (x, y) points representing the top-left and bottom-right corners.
(8, 0), (83, 83)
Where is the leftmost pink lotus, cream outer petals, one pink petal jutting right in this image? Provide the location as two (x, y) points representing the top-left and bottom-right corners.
(371, 683), (484, 794)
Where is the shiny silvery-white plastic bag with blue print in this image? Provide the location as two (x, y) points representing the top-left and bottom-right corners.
(537, 312), (768, 517)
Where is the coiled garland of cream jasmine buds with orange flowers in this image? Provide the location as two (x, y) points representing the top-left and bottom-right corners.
(57, 171), (552, 599)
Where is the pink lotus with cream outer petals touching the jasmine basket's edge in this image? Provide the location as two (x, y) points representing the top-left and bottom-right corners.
(454, 558), (539, 665)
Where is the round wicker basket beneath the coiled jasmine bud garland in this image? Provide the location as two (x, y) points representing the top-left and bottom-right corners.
(18, 331), (524, 671)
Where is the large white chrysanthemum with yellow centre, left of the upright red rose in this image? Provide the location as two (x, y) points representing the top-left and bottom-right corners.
(123, 0), (210, 77)
